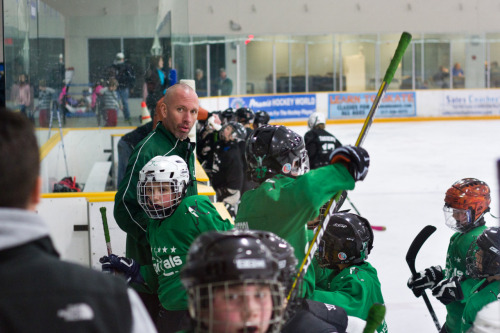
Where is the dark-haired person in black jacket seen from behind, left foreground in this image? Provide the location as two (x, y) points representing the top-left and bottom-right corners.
(0, 108), (156, 332)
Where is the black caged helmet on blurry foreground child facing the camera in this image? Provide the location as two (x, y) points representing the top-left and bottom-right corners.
(180, 230), (285, 333)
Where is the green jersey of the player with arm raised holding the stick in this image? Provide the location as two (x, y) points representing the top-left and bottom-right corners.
(235, 163), (354, 297)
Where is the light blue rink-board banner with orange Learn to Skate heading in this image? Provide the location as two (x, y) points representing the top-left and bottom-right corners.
(328, 91), (416, 119)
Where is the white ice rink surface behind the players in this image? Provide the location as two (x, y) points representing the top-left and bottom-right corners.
(290, 120), (500, 333)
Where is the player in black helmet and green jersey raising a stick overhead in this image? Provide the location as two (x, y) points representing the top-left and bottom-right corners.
(235, 125), (369, 296)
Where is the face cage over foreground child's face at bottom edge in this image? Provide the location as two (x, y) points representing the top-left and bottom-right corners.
(188, 279), (285, 333)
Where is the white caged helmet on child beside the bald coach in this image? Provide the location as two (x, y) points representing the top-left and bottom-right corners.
(137, 155), (189, 219)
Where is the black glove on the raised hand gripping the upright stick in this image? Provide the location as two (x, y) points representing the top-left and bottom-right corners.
(330, 146), (370, 181)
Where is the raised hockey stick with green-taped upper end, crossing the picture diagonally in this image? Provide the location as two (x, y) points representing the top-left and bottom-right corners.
(287, 32), (411, 304)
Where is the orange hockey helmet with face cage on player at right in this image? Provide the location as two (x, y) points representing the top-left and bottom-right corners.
(443, 178), (491, 233)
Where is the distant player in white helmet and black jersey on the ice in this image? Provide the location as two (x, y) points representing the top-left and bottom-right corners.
(304, 112), (342, 169)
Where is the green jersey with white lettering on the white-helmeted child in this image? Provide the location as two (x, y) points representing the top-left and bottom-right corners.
(146, 195), (233, 311)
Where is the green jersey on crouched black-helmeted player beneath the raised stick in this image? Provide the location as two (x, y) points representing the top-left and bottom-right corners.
(310, 261), (387, 333)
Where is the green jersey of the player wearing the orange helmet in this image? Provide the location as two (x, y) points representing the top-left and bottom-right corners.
(445, 226), (486, 333)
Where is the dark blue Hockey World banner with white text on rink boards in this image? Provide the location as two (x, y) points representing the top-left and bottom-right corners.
(229, 94), (316, 120)
